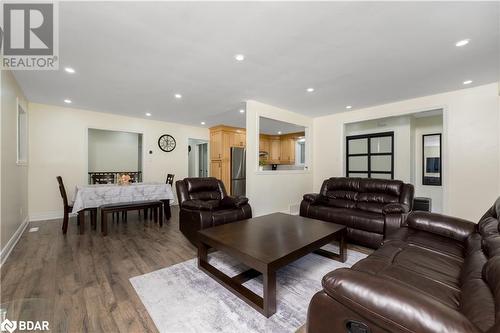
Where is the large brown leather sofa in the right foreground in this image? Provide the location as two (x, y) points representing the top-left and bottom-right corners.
(307, 199), (500, 333)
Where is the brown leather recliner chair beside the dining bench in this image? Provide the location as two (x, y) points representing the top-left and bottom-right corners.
(175, 177), (252, 246)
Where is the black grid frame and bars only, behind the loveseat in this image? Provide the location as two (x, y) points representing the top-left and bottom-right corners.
(345, 131), (394, 179)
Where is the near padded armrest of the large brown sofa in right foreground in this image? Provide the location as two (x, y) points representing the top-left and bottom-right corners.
(322, 268), (480, 333)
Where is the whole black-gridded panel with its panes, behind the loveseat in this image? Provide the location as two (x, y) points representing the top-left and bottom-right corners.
(346, 132), (394, 179)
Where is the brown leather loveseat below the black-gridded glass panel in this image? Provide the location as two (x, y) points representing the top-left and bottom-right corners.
(300, 177), (414, 248)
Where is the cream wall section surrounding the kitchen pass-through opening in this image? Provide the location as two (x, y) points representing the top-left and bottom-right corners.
(246, 101), (313, 216)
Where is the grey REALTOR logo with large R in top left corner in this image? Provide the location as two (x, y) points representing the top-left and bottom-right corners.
(0, 2), (59, 70)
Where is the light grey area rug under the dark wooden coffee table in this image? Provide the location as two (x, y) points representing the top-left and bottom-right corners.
(130, 245), (366, 333)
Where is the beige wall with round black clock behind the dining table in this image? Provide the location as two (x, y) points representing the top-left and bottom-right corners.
(29, 103), (209, 219)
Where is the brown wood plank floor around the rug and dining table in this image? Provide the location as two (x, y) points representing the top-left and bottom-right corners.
(0, 207), (371, 333)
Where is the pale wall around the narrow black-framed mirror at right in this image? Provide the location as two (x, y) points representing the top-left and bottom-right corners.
(412, 116), (444, 213)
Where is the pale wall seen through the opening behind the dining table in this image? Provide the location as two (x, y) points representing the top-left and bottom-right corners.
(88, 128), (142, 172)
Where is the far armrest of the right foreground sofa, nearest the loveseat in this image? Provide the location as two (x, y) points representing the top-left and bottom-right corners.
(406, 211), (476, 242)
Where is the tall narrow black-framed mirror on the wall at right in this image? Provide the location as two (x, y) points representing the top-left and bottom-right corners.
(422, 133), (443, 186)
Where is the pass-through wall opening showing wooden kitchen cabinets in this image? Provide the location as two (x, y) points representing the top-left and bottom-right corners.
(259, 117), (307, 171)
